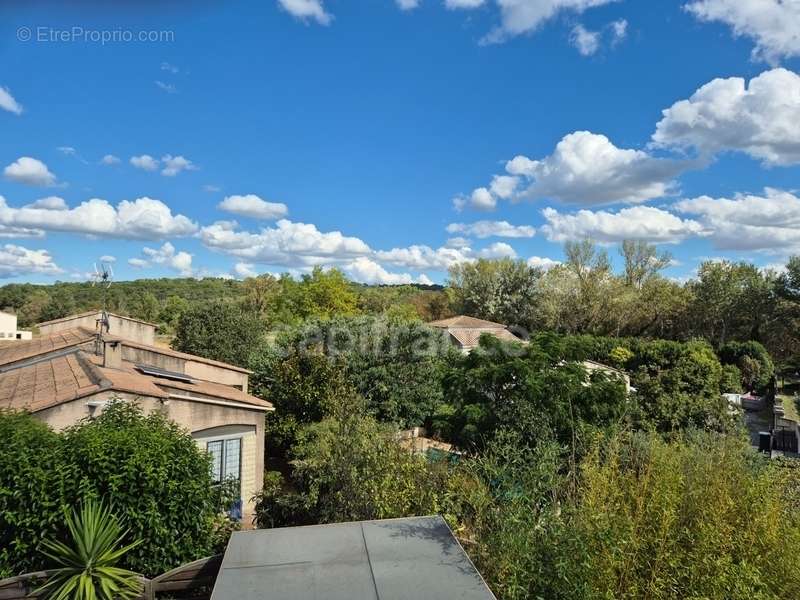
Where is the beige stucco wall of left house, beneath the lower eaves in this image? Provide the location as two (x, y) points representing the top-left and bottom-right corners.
(35, 392), (265, 527)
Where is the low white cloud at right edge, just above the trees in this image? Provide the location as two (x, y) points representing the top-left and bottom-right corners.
(675, 188), (800, 252)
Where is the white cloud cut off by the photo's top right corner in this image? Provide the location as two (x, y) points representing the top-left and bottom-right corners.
(685, 0), (800, 64)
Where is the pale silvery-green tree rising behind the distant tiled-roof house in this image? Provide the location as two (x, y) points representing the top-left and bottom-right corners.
(448, 258), (542, 329)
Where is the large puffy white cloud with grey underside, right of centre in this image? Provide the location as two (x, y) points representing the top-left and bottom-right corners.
(473, 131), (691, 206)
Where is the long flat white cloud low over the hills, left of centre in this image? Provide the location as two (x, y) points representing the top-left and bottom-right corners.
(200, 219), (372, 267)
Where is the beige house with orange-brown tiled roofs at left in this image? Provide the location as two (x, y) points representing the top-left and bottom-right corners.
(0, 313), (273, 524)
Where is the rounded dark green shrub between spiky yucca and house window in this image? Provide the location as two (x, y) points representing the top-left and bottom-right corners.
(64, 402), (220, 576)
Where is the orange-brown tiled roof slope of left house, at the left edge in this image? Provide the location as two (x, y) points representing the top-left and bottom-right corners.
(0, 351), (101, 412)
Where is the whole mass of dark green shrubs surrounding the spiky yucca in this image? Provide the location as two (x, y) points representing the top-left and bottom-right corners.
(0, 403), (227, 576)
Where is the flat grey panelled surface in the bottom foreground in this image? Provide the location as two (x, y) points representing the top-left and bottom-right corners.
(211, 516), (494, 600)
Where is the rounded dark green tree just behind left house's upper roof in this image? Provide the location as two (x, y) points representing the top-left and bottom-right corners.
(172, 301), (264, 366)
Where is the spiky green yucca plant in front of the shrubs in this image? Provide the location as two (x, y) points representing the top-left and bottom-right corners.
(34, 500), (142, 600)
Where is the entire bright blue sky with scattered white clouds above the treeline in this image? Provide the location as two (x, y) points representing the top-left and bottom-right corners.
(0, 0), (800, 283)
